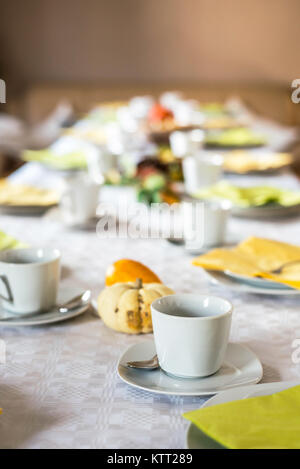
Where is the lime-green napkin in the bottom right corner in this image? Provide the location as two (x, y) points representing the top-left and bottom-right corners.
(184, 386), (300, 449)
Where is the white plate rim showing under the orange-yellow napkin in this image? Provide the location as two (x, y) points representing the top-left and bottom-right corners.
(205, 270), (300, 296)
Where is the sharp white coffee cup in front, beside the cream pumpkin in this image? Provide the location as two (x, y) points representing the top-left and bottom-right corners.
(151, 294), (233, 378)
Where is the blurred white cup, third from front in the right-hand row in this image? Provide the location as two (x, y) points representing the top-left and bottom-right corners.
(182, 153), (223, 195)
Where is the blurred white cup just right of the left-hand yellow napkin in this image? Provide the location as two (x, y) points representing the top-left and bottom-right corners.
(60, 175), (100, 225)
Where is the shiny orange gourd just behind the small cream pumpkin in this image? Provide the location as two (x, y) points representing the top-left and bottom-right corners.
(105, 259), (162, 286)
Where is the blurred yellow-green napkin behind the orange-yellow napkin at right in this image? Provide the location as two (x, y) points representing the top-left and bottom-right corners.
(195, 181), (300, 207)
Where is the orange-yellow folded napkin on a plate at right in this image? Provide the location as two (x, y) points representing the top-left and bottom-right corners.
(193, 237), (300, 289)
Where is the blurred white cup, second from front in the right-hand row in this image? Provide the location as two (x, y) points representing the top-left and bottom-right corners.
(182, 200), (232, 250)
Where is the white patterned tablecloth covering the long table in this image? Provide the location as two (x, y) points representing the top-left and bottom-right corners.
(0, 165), (300, 449)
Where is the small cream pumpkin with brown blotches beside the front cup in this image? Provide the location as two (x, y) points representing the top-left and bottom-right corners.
(98, 279), (174, 334)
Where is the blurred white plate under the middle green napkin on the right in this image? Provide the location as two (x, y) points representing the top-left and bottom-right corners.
(232, 204), (300, 219)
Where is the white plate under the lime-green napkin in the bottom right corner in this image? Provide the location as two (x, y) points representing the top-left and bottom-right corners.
(186, 381), (300, 449)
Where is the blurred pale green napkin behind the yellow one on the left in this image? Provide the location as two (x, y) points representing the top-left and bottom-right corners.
(23, 149), (87, 170)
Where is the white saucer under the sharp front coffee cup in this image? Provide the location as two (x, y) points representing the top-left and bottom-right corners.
(117, 341), (263, 396)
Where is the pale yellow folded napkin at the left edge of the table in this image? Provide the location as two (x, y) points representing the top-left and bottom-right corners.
(0, 179), (59, 206)
